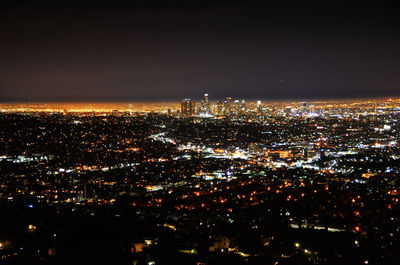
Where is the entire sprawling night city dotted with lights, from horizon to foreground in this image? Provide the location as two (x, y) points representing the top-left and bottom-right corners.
(0, 94), (400, 264)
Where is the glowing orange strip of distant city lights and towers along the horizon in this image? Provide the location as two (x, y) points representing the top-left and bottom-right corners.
(0, 94), (400, 111)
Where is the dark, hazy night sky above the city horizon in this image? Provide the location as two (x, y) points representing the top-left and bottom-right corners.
(0, 0), (400, 102)
